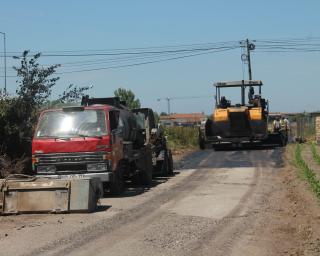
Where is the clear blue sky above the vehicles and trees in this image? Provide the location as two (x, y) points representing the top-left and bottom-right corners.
(0, 0), (320, 114)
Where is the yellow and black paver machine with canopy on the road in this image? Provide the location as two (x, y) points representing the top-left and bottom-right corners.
(199, 80), (286, 149)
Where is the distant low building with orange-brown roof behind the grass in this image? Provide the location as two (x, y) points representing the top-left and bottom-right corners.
(160, 113), (207, 126)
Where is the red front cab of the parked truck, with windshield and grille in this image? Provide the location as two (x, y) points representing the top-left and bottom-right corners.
(32, 105), (122, 181)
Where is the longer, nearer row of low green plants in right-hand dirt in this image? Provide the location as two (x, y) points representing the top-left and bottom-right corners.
(295, 144), (320, 199)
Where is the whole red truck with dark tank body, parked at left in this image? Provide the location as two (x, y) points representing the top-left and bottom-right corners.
(32, 96), (162, 195)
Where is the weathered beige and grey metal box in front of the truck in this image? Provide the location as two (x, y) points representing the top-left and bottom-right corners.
(0, 178), (102, 214)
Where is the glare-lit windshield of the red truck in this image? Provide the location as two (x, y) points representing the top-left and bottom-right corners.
(35, 110), (108, 138)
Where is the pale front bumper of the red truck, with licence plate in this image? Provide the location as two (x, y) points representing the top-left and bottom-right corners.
(36, 172), (113, 182)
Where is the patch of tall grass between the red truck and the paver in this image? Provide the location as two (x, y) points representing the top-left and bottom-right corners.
(164, 126), (198, 150)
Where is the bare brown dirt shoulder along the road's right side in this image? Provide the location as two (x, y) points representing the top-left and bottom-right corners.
(242, 145), (320, 255)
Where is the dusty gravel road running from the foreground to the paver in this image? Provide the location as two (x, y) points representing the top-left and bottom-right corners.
(0, 149), (318, 256)
